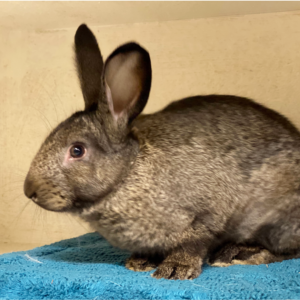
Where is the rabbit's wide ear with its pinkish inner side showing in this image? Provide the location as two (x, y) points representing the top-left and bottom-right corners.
(103, 43), (151, 126)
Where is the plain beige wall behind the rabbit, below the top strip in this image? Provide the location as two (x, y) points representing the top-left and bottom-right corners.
(0, 7), (300, 251)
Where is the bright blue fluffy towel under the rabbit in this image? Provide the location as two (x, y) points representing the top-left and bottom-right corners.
(0, 233), (300, 300)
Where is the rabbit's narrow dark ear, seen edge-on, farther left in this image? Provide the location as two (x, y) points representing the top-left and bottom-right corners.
(75, 24), (103, 110)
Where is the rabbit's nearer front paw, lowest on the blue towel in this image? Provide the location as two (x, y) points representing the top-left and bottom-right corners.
(152, 262), (201, 280)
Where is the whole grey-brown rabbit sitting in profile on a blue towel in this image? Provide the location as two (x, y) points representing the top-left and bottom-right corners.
(24, 24), (300, 280)
